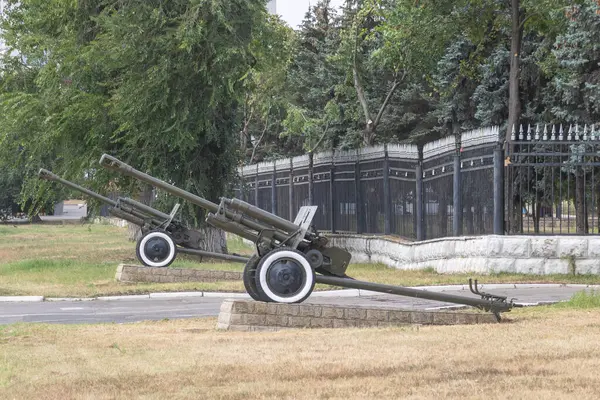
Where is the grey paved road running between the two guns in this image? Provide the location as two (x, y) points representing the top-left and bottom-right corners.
(0, 287), (584, 324)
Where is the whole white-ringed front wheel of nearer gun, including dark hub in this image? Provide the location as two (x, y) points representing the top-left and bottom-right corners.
(256, 248), (315, 303)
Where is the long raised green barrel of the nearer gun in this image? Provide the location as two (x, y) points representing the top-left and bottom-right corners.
(100, 154), (298, 241)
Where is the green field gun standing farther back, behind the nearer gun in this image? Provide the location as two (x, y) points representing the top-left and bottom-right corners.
(38, 168), (248, 267)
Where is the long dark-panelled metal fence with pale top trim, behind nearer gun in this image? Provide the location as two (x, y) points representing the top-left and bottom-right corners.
(236, 127), (504, 240)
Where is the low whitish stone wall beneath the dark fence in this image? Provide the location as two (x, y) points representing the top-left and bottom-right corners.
(328, 234), (600, 276)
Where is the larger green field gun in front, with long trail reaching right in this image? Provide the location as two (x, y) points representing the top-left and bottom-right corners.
(100, 154), (516, 319)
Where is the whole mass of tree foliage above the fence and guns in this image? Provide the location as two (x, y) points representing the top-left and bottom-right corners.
(0, 0), (600, 214)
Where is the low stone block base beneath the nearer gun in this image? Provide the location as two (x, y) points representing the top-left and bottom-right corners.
(217, 300), (497, 331)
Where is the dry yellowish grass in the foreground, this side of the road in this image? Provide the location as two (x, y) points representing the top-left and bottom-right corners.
(0, 309), (600, 400)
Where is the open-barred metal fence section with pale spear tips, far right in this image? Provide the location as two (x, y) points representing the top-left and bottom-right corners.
(506, 125), (600, 235)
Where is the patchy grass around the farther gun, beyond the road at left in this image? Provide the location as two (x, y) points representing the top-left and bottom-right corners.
(0, 225), (244, 297)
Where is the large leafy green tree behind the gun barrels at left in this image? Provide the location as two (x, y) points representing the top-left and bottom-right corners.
(0, 0), (266, 250)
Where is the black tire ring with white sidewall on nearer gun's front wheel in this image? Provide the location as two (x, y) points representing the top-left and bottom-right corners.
(255, 247), (315, 303)
